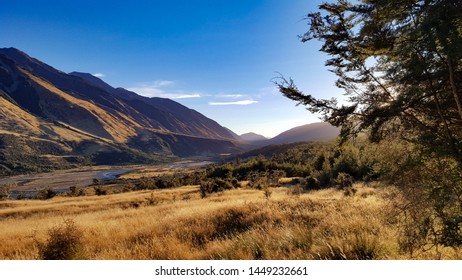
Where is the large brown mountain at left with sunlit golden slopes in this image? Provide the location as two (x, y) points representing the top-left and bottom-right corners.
(0, 48), (238, 173)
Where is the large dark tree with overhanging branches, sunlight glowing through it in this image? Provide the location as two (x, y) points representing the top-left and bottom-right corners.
(276, 0), (462, 163)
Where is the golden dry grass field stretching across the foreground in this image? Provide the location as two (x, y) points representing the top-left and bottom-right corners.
(0, 185), (462, 260)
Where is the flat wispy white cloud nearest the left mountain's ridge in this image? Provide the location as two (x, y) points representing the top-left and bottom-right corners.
(128, 80), (201, 99)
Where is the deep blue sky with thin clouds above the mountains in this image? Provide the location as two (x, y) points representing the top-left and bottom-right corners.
(0, 0), (341, 137)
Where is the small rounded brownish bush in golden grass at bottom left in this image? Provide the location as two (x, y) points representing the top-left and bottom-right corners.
(37, 219), (85, 260)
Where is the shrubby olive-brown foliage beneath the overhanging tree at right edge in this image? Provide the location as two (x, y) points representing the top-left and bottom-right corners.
(397, 155), (462, 253)
